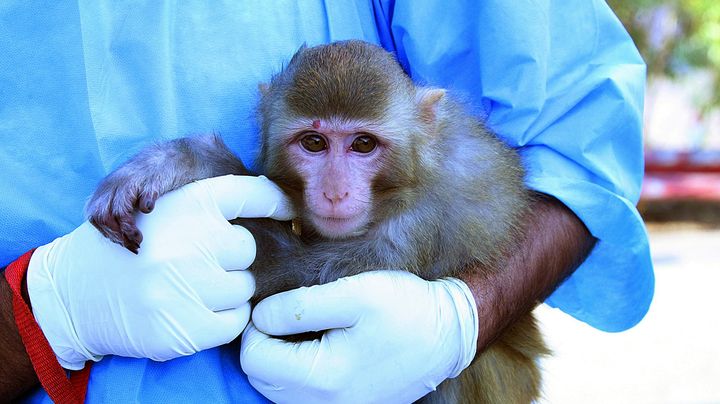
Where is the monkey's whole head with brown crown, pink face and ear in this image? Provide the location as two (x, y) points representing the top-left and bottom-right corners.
(259, 41), (442, 239)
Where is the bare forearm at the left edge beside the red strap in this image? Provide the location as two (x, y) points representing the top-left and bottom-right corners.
(0, 271), (38, 401)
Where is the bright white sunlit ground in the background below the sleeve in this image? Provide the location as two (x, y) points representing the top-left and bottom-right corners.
(537, 221), (720, 404)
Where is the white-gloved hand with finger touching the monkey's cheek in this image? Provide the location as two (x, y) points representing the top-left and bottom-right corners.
(27, 176), (293, 369)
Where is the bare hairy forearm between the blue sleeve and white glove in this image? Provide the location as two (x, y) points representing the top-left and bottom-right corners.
(463, 195), (596, 352)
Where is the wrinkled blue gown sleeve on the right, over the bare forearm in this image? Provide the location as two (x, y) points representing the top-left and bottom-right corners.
(375, 0), (654, 331)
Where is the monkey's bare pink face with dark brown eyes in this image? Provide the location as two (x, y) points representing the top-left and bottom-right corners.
(289, 120), (385, 238)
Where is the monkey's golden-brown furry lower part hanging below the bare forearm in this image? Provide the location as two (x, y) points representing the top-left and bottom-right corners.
(418, 314), (550, 404)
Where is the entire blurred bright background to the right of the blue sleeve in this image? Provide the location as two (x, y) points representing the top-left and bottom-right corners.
(537, 0), (720, 404)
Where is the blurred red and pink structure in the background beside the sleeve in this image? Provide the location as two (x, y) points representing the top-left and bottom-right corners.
(640, 150), (720, 202)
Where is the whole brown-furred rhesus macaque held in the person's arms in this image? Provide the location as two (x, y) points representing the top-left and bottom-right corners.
(87, 41), (547, 403)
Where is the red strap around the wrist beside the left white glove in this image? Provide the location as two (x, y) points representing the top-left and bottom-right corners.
(5, 250), (92, 404)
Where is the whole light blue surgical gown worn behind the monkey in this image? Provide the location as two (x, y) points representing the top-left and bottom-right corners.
(0, 0), (653, 402)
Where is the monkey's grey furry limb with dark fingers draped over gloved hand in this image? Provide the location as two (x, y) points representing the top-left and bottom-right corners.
(85, 135), (247, 253)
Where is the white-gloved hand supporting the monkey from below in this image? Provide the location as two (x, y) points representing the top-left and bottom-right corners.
(240, 271), (478, 403)
